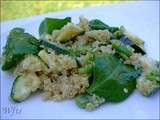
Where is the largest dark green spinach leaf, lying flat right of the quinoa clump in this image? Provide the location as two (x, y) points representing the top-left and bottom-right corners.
(88, 54), (141, 102)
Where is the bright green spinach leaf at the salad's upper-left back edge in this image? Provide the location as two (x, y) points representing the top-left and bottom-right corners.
(39, 17), (71, 36)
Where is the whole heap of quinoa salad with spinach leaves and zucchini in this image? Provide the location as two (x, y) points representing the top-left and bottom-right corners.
(2, 16), (160, 110)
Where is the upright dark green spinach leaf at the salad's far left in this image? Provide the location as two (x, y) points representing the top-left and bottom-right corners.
(2, 28), (39, 70)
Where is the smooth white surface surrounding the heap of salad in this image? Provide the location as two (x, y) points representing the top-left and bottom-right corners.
(1, 1), (160, 119)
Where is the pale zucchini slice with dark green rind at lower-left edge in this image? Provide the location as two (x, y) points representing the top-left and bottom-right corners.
(10, 73), (41, 102)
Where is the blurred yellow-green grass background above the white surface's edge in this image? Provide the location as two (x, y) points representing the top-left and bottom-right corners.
(0, 0), (127, 21)
